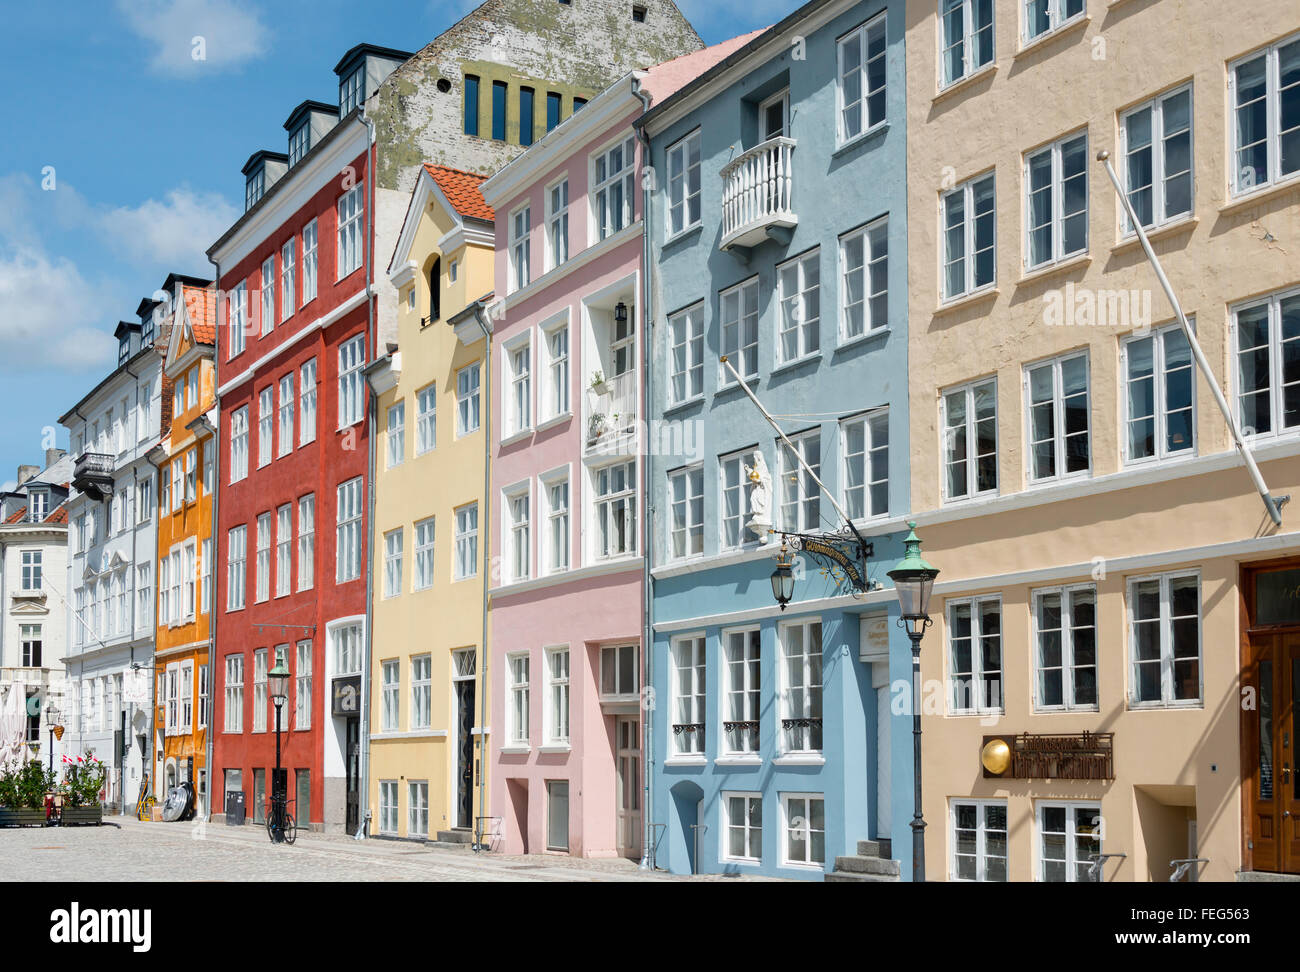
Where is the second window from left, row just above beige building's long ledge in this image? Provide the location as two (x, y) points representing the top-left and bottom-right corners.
(1024, 353), (1091, 482)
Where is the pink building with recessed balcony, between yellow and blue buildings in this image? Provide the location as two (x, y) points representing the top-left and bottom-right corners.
(482, 36), (749, 858)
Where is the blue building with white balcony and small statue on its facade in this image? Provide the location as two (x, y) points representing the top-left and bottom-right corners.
(640, 0), (913, 880)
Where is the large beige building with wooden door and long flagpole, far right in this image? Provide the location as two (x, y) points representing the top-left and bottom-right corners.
(891, 0), (1300, 881)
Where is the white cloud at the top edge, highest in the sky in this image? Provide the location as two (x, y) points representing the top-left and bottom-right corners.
(117, 0), (270, 77)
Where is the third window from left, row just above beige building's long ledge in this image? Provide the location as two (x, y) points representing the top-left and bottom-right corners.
(1123, 326), (1196, 463)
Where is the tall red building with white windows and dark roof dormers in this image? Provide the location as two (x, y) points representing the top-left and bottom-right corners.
(208, 108), (373, 832)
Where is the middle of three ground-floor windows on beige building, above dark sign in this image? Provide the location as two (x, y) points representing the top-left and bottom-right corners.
(1034, 583), (1097, 710)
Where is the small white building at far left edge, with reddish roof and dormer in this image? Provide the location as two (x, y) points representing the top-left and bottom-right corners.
(0, 450), (73, 765)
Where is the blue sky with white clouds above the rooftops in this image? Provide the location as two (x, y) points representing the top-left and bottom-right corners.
(0, 0), (780, 483)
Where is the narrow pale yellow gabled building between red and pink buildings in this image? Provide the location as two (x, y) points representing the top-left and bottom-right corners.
(367, 165), (494, 842)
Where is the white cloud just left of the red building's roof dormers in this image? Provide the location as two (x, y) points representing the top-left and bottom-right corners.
(96, 186), (239, 268)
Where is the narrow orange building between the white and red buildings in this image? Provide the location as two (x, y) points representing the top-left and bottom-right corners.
(150, 277), (217, 813)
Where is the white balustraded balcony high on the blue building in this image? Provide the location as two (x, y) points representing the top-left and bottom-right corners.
(718, 136), (800, 249)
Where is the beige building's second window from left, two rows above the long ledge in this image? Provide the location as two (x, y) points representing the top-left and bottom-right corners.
(1024, 133), (1088, 269)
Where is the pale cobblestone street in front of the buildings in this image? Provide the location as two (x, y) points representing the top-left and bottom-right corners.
(0, 819), (780, 881)
